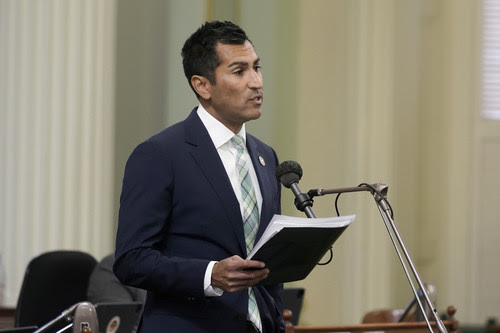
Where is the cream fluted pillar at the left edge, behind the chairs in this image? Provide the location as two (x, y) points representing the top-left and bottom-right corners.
(0, 0), (116, 305)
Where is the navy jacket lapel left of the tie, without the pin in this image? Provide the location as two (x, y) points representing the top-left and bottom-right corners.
(184, 108), (246, 254)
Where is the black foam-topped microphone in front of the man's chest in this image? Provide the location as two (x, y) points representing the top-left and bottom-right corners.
(275, 161), (316, 218)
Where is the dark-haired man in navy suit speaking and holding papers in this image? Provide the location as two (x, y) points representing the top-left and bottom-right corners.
(114, 21), (285, 333)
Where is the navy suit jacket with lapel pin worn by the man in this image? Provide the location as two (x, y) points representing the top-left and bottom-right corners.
(114, 108), (285, 333)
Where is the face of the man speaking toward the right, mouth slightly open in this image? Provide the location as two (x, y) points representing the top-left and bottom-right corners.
(206, 41), (263, 133)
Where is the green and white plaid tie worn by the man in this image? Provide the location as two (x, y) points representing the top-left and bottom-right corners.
(231, 135), (262, 332)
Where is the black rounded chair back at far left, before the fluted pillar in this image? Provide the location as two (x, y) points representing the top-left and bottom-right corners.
(15, 250), (97, 327)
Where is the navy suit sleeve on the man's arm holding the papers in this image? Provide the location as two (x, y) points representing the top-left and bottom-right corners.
(113, 141), (208, 296)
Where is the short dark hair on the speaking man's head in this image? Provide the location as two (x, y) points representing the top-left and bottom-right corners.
(181, 21), (251, 96)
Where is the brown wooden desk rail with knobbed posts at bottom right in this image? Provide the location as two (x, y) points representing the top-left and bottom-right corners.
(283, 306), (458, 333)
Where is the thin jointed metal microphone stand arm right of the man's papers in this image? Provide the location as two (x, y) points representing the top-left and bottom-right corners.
(307, 183), (448, 333)
